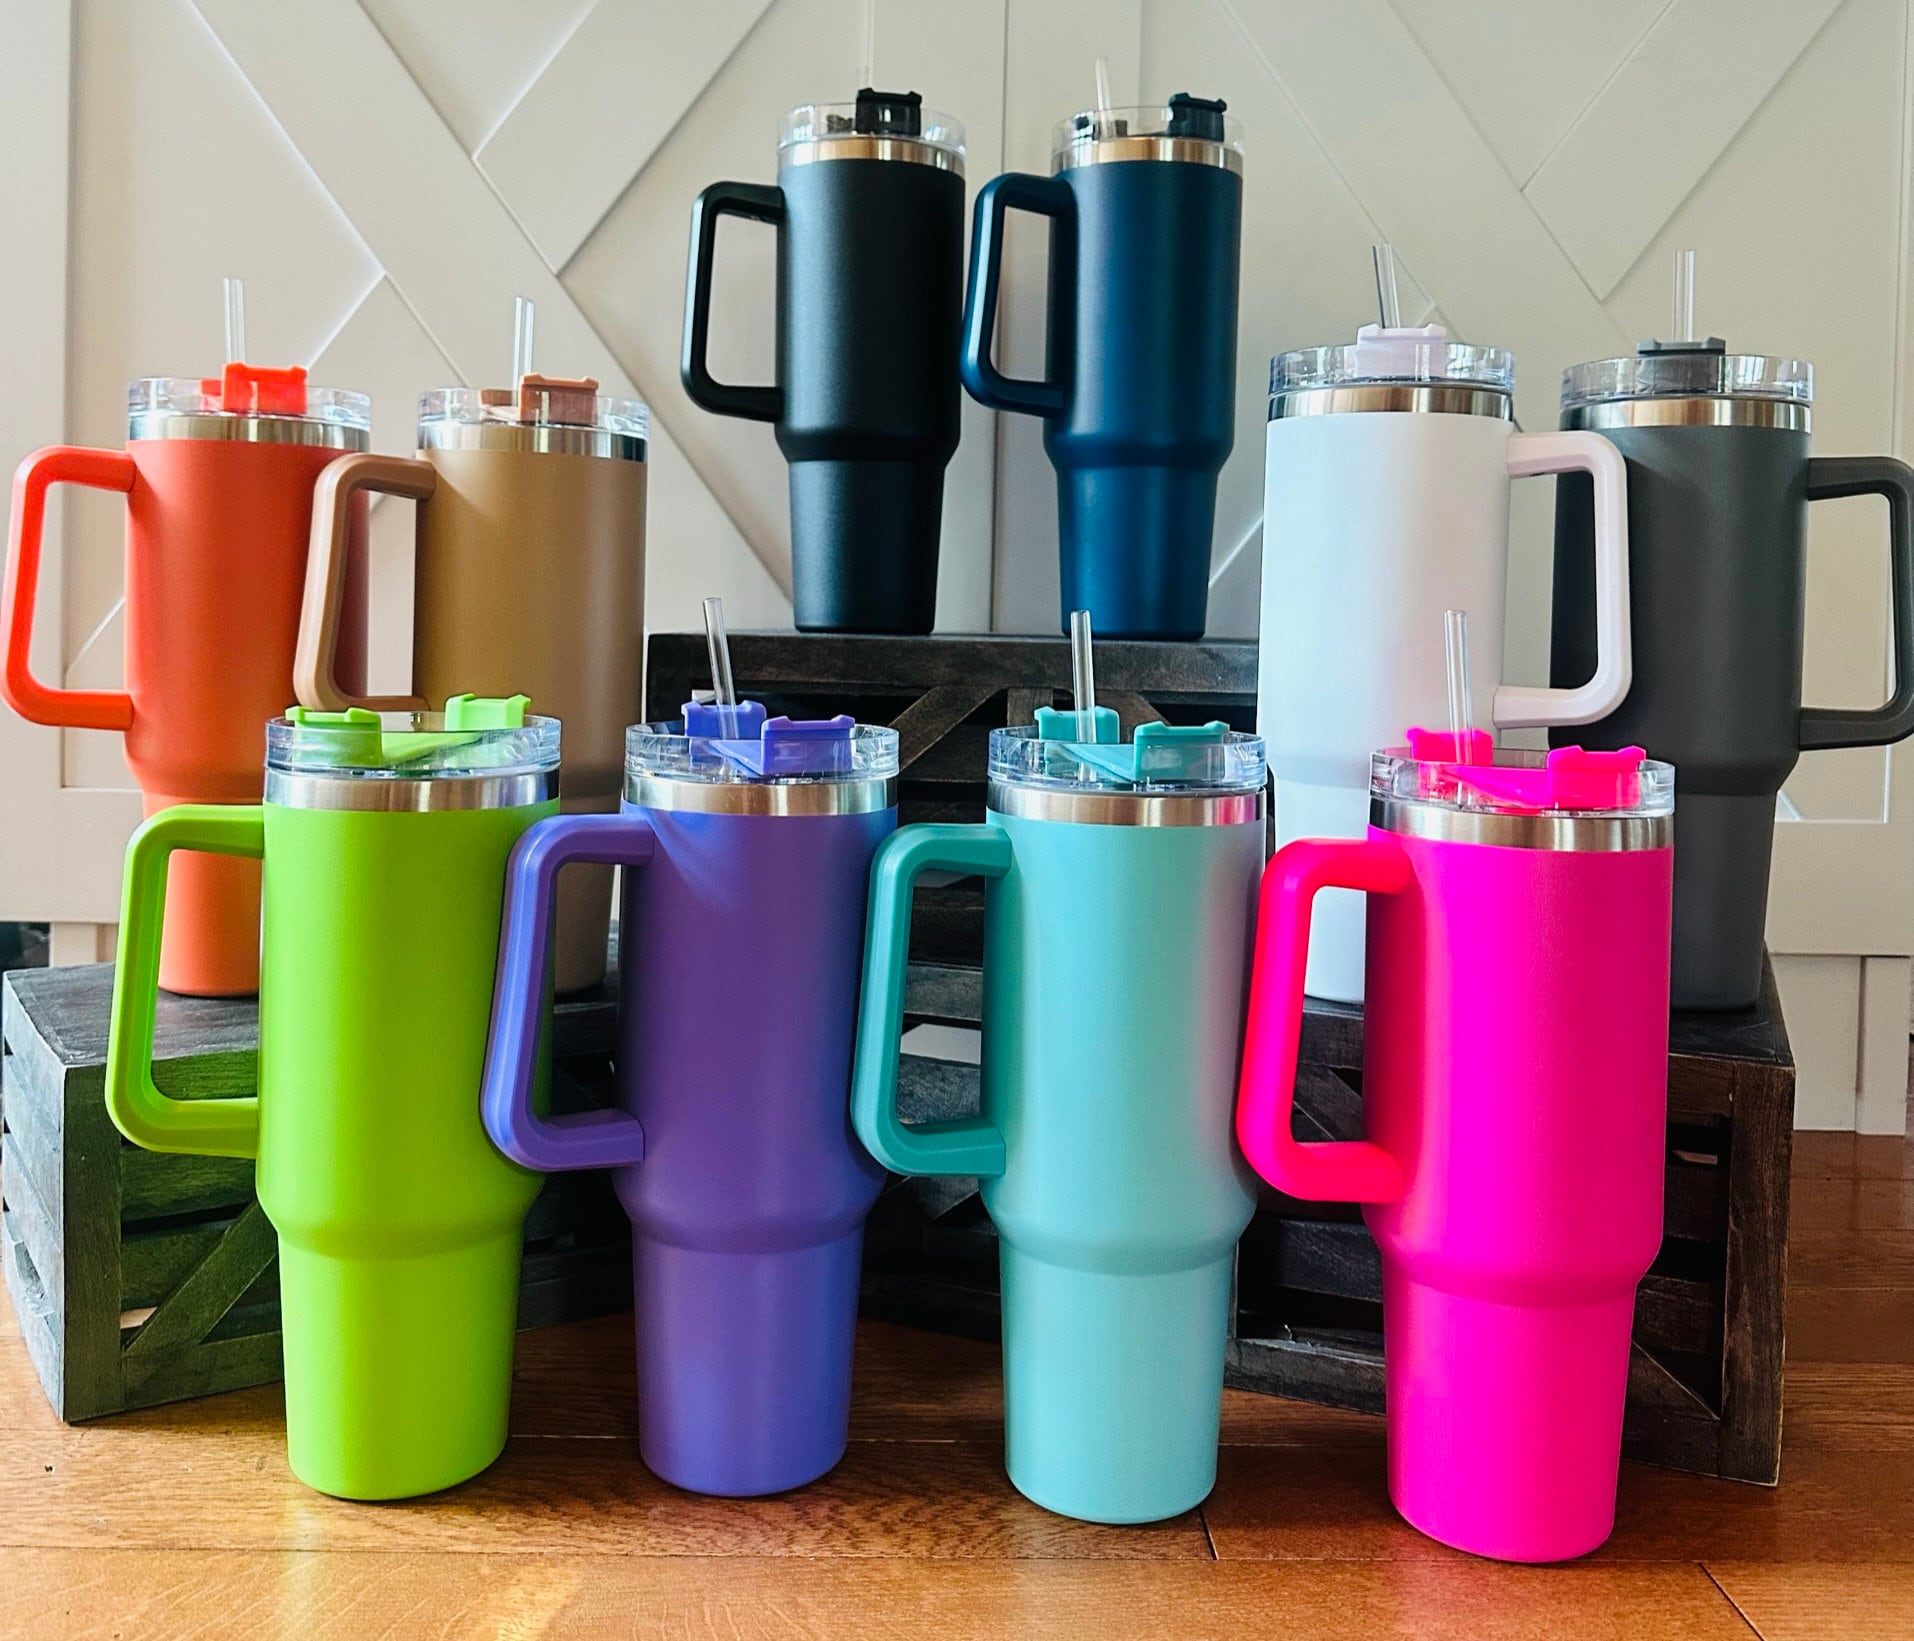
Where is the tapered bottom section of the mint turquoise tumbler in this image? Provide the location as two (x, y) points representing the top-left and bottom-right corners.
(1001, 1243), (1231, 1524)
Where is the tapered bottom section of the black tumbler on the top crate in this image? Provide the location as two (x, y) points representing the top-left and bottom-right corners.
(790, 461), (944, 634)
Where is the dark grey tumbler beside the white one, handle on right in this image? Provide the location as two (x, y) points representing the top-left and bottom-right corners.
(1550, 337), (1914, 1009)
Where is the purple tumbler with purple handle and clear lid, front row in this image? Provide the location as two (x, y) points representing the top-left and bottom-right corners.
(484, 701), (898, 1495)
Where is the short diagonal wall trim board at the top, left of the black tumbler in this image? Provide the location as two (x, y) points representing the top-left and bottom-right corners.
(473, 0), (771, 270)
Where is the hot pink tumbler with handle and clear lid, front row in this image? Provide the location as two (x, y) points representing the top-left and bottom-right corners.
(1236, 731), (1675, 1561)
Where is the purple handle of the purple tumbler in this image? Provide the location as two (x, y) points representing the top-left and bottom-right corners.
(479, 814), (657, 1174)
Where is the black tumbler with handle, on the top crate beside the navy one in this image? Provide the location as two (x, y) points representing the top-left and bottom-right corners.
(679, 90), (963, 632)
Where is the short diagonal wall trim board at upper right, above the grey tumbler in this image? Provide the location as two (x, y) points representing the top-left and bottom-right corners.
(1524, 0), (1841, 299)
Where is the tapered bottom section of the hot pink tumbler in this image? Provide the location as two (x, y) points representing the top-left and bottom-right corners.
(1382, 1266), (1635, 1561)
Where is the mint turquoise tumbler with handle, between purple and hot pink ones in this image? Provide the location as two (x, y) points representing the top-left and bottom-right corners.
(852, 708), (1263, 1522)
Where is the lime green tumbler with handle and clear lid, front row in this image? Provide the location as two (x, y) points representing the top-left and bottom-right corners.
(107, 695), (559, 1499)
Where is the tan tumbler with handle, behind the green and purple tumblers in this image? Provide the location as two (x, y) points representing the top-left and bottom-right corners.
(293, 375), (647, 992)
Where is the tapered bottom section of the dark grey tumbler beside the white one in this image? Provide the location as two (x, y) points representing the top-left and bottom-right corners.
(1669, 777), (1774, 1009)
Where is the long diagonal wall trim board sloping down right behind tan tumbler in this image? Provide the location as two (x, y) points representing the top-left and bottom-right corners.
(193, 0), (789, 596)
